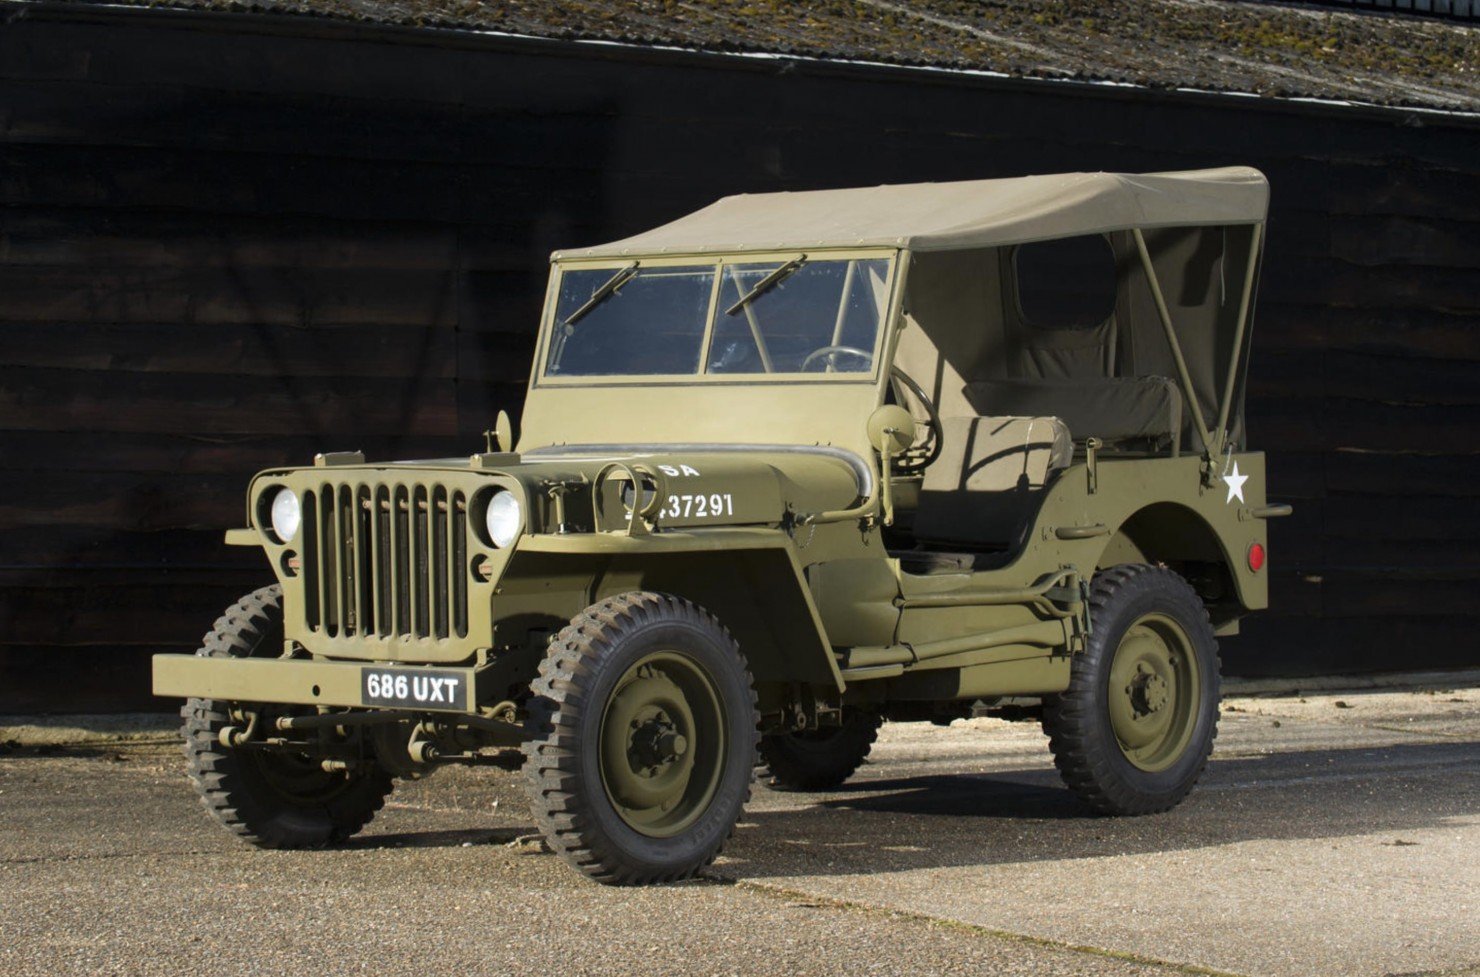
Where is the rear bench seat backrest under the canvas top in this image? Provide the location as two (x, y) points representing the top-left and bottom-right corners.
(965, 376), (1183, 441)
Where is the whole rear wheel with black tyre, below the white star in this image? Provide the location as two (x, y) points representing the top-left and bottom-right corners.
(1043, 564), (1220, 814)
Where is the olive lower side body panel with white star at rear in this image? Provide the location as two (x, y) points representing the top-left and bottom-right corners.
(811, 453), (1268, 699)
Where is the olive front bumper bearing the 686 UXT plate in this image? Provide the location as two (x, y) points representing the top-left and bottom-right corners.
(154, 654), (482, 714)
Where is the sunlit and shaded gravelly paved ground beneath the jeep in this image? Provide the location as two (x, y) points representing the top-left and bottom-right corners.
(0, 688), (1480, 977)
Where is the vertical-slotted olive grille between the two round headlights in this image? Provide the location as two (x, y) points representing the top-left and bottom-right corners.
(303, 484), (468, 638)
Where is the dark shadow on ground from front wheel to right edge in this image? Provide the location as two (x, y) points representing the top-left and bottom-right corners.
(719, 742), (1480, 879)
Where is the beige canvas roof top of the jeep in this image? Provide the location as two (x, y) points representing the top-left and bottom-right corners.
(555, 166), (1270, 258)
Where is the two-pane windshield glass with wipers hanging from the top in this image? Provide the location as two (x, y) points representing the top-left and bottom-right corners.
(545, 256), (889, 377)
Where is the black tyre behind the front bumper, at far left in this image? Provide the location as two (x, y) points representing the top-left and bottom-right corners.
(181, 585), (394, 848)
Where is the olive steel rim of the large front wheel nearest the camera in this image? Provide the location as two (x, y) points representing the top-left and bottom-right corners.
(598, 651), (728, 838)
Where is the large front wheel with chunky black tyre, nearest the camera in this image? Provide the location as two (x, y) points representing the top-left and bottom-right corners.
(524, 592), (758, 885)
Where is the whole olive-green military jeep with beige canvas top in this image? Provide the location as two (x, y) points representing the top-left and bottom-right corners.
(154, 169), (1289, 884)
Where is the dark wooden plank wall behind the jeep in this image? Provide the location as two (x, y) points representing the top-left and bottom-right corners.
(0, 6), (1480, 712)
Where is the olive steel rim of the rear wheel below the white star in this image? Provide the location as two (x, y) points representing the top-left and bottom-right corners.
(1107, 614), (1202, 773)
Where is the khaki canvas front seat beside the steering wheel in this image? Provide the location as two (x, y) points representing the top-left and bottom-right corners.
(915, 417), (1073, 551)
